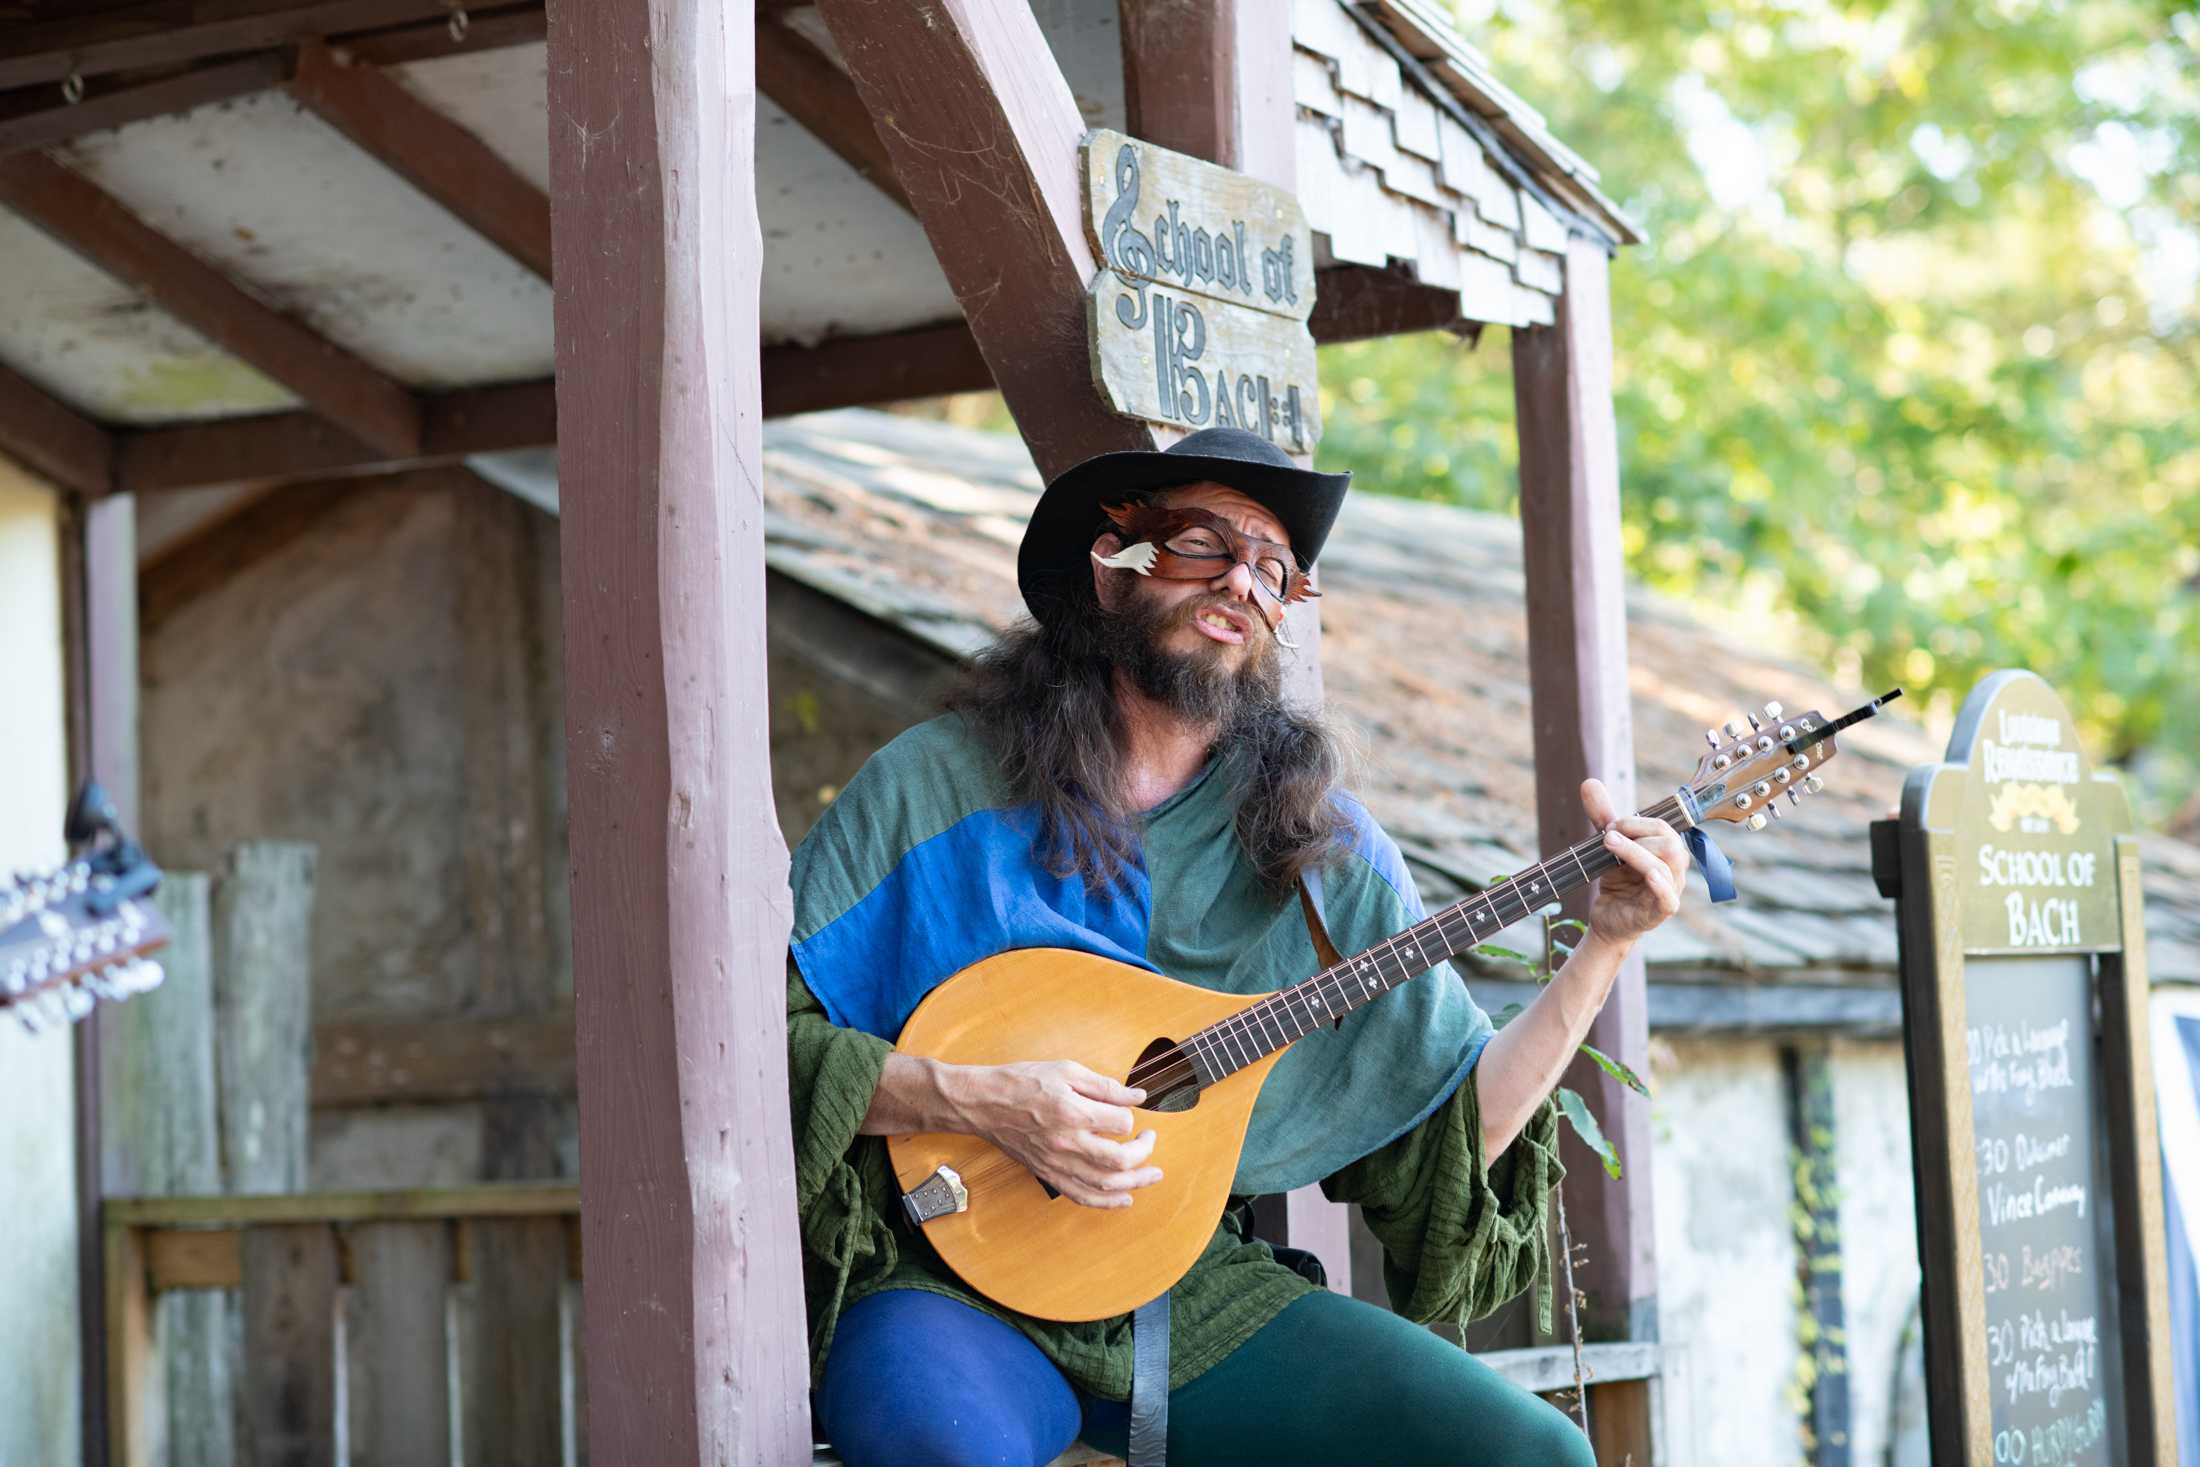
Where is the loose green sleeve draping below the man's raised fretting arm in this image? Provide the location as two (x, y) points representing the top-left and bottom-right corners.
(1322, 1069), (1566, 1331)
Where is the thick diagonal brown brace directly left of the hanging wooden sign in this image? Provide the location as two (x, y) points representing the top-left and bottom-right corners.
(818, 0), (1155, 475)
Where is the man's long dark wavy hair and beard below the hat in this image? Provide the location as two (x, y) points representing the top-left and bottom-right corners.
(948, 576), (1344, 897)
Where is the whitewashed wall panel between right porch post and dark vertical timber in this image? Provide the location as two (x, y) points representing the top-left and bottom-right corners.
(1650, 1038), (1804, 1467)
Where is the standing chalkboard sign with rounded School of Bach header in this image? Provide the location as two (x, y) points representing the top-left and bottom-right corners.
(1872, 671), (2176, 1467)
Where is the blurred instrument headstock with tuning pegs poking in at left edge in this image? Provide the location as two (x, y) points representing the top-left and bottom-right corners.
(0, 785), (169, 1034)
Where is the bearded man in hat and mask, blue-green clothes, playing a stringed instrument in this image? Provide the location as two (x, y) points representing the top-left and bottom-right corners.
(788, 429), (1687, 1467)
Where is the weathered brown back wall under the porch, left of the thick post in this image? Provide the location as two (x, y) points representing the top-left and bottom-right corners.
(143, 475), (576, 1185)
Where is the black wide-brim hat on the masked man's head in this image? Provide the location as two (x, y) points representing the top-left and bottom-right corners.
(1016, 429), (1353, 620)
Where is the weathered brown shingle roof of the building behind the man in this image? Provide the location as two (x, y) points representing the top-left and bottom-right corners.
(763, 409), (2200, 983)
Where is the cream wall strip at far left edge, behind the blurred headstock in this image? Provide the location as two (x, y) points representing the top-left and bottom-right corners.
(0, 462), (79, 1467)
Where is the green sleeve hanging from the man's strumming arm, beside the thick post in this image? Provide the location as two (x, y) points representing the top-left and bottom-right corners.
(788, 959), (895, 1372)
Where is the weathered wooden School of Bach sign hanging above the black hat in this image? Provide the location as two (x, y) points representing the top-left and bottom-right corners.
(1085, 130), (1322, 453)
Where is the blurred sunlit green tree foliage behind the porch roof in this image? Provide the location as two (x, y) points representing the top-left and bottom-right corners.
(1322, 0), (2200, 818)
